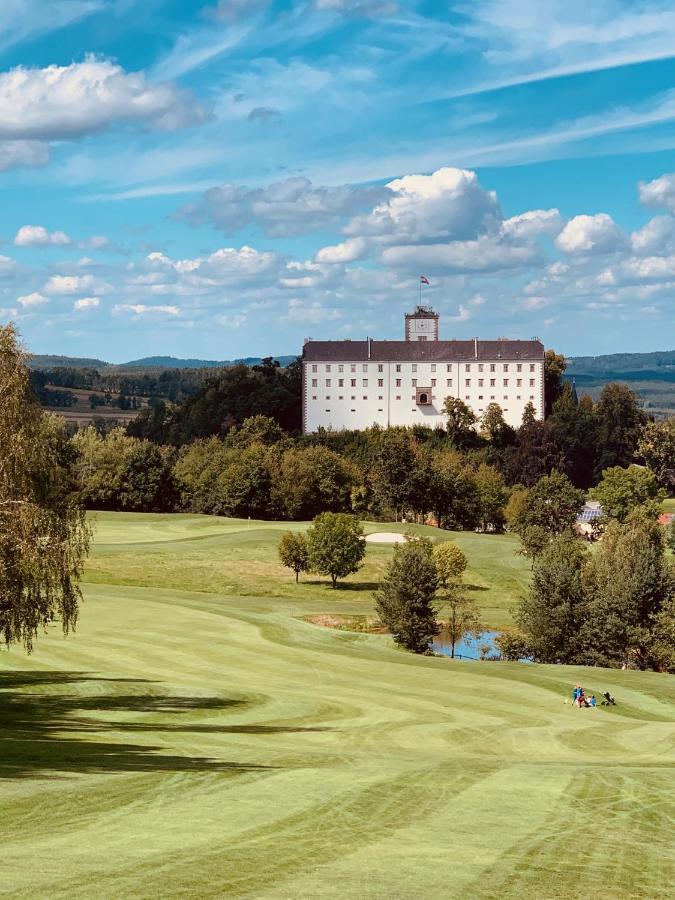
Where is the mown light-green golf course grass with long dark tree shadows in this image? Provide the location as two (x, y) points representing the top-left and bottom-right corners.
(0, 514), (675, 900)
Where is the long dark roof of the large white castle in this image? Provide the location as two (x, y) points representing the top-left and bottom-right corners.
(302, 341), (544, 362)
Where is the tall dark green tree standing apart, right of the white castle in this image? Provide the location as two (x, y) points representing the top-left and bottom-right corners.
(594, 384), (647, 481)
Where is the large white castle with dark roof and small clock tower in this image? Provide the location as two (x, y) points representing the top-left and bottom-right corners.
(302, 306), (544, 433)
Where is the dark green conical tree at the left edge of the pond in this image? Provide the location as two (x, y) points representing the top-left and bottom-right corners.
(375, 538), (438, 653)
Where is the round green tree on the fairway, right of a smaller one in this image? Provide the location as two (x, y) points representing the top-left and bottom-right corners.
(307, 512), (366, 587)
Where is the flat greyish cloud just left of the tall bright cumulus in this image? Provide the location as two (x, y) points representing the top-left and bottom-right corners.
(176, 177), (388, 237)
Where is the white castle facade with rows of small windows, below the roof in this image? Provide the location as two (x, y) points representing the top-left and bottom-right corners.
(303, 359), (544, 432)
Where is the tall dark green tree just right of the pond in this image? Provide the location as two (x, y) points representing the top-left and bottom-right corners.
(515, 535), (586, 663)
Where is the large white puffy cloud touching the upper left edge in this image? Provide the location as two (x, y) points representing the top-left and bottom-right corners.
(0, 57), (205, 141)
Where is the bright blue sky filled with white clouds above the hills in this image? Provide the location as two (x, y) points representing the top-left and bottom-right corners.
(0, 0), (675, 362)
